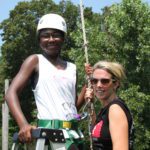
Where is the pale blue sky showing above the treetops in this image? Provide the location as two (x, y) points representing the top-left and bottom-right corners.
(0, 0), (150, 46)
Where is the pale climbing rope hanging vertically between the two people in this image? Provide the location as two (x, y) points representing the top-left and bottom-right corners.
(80, 0), (94, 150)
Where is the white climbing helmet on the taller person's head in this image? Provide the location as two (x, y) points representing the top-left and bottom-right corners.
(37, 14), (67, 33)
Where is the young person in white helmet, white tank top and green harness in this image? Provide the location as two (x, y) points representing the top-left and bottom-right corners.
(5, 14), (83, 149)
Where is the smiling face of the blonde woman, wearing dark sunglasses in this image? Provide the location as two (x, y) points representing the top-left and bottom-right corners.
(91, 69), (118, 101)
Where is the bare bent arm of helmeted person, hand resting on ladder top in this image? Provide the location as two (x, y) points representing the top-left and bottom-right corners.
(5, 55), (38, 142)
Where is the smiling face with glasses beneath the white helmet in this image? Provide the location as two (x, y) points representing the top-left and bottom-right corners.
(39, 29), (64, 57)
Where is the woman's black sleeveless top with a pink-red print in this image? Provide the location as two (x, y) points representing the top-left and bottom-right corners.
(92, 98), (133, 150)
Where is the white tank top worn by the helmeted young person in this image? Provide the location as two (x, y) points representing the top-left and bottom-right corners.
(33, 54), (77, 120)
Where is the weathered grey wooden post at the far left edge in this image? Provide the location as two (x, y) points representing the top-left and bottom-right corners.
(2, 79), (9, 150)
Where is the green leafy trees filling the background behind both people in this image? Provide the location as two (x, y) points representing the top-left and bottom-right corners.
(0, 0), (150, 150)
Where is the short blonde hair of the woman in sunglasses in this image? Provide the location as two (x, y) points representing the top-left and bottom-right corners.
(93, 61), (126, 82)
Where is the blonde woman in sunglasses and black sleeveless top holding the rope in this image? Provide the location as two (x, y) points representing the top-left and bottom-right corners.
(85, 61), (133, 150)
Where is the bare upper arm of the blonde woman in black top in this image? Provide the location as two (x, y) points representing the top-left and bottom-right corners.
(109, 104), (129, 150)
